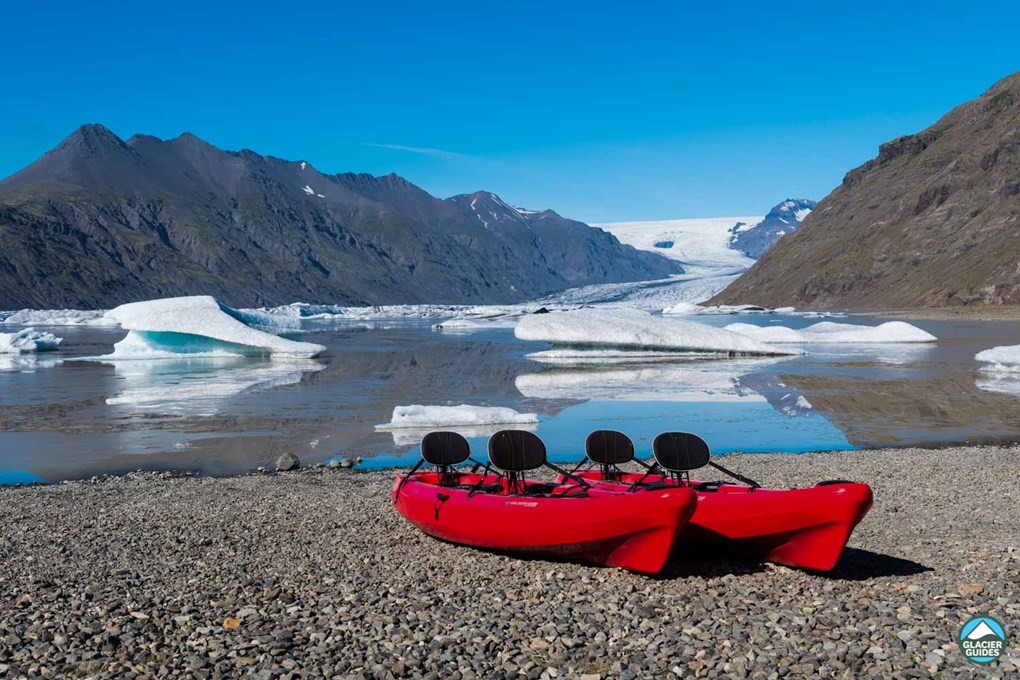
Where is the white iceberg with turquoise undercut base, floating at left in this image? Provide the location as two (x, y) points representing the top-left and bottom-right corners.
(99, 296), (325, 359)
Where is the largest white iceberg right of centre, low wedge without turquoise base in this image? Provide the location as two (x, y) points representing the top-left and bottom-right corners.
(514, 308), (800, 356)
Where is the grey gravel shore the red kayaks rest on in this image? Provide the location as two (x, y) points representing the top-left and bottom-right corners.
(0, 448), (1020, 680)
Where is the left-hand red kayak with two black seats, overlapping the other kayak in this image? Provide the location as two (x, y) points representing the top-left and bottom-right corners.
(392, 430), (697, 573)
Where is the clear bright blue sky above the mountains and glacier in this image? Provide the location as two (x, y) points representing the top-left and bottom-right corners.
(0, 0), (1020, 221)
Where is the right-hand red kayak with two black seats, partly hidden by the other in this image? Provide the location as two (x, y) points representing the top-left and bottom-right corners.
(575, 430), (873, 571)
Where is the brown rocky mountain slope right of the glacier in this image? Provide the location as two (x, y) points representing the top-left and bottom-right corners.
(711, 73), (1020, 308)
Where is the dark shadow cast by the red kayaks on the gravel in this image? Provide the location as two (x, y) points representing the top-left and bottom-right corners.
(652, 545), (934, 581)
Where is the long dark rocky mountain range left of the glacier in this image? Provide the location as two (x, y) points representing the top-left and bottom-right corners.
(0, 125), (681, 309)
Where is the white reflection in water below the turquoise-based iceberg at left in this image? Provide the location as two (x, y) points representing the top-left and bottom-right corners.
(100, 357), (325, 416)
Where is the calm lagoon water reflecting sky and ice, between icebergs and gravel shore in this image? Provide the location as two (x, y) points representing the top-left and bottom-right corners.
(0, 315), (1020, 484)
